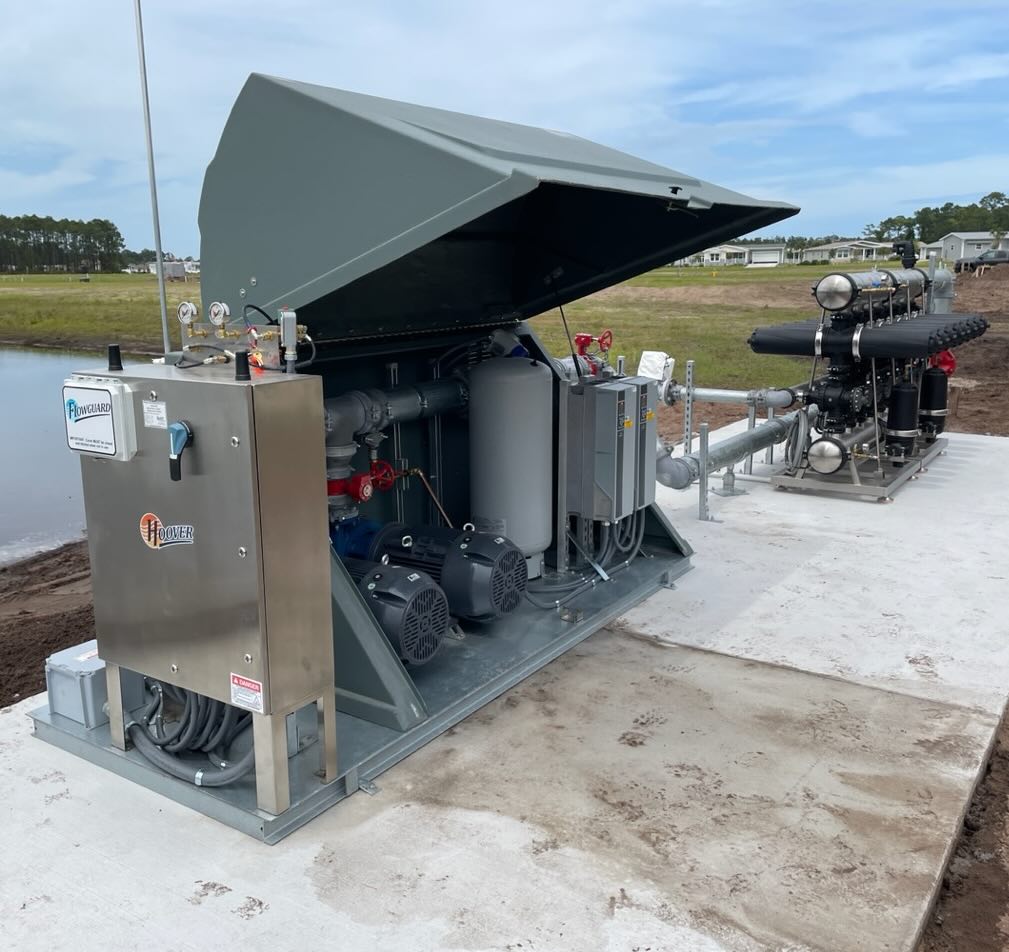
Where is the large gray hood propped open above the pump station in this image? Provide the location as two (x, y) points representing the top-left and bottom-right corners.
(200, 74), (798, 341)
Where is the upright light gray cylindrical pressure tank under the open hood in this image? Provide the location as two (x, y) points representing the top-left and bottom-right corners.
(469, 357), (554, 578)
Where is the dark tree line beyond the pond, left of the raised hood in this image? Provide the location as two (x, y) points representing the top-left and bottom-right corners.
(0, 215), (175, 273)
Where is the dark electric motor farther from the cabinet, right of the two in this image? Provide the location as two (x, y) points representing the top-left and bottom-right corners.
(368, 522), (528, 621)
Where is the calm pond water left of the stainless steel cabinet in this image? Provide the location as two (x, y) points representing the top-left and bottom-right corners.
(0, 347), (95, 565)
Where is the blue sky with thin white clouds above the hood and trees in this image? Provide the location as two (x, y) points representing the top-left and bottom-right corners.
(0, 0), (1009, 255)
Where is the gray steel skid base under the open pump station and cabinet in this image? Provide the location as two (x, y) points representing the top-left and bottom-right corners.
(31, 545), (690, 843)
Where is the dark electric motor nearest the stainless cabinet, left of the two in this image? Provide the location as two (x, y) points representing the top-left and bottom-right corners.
(342, 559), (449, 666)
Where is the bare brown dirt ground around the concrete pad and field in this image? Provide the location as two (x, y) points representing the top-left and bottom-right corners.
(0, 268), (1009, 952)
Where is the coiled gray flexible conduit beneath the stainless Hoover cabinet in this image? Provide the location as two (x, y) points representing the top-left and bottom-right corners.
(126, 681), (255, 787)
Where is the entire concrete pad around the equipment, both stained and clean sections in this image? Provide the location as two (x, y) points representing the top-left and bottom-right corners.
(0, 435), (1009, 952)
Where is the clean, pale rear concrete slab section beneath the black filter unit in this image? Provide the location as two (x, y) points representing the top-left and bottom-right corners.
(625, 428), (1009, 714)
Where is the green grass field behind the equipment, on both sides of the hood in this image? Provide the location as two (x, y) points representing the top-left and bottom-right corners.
(0, 265), (826, 386)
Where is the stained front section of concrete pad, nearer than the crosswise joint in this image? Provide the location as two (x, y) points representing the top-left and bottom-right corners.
(0, 631), (995, 952)
